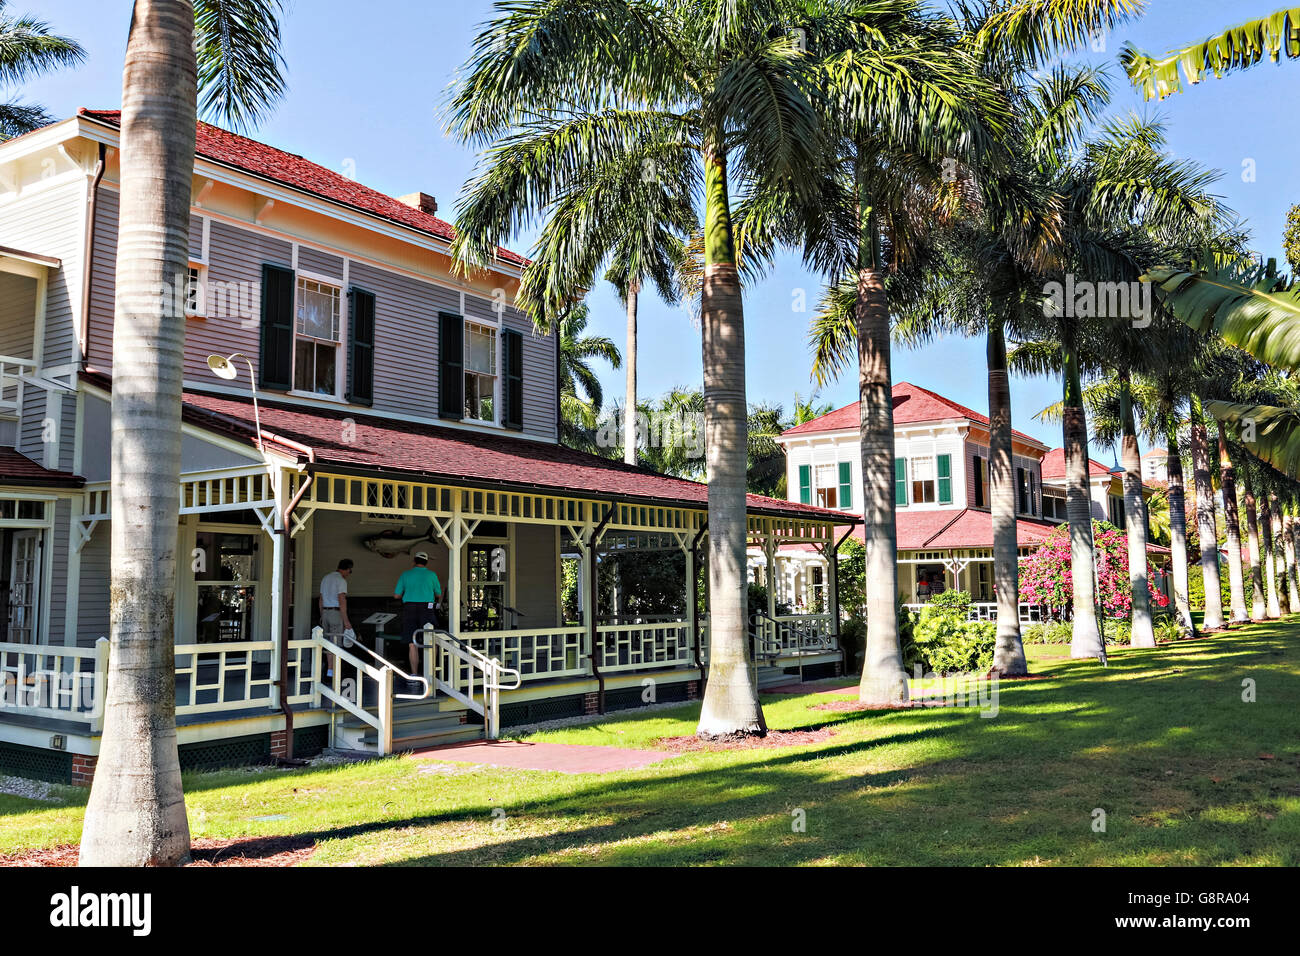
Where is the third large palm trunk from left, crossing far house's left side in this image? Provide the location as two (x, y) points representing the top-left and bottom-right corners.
(857, 196), (909, 705)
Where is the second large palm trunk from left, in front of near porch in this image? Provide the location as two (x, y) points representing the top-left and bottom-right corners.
(696, 137), (767, 739)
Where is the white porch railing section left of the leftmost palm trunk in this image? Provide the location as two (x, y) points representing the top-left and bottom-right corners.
(0, 637), (108, 731)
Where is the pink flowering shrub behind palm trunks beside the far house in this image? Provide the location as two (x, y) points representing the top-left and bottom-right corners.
(1021, 519), (1169, 619)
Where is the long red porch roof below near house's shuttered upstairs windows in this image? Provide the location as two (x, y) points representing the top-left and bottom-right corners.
(82, 371), (862, 524)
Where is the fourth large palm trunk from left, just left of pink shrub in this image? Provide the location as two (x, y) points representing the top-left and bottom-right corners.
(988, 320), (1030, 678)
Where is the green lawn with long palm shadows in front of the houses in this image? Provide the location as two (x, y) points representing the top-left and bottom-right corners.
(0, 623), (1300, 865)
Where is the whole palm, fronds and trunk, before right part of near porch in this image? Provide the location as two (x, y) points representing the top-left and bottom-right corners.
(450, 0), (822, 737)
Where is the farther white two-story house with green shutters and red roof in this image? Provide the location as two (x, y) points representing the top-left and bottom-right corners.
(750, 382), (1164, 620)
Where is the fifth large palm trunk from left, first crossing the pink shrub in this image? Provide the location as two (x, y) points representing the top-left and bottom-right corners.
(1061, 324), (1105, 657)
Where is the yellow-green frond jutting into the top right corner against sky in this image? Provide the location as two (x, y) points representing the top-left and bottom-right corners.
(1119, 8), (1300, 100)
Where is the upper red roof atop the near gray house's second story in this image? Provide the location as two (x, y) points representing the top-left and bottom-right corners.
(78, 108), (528, 265)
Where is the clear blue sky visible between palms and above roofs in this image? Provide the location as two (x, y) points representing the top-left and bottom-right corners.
(9, 0), (1300, 463)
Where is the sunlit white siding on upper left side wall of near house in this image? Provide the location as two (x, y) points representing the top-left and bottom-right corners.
(0, 181), (86, 365)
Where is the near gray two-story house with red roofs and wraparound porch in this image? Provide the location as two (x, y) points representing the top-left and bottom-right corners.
(0, 111), (853, 780)
